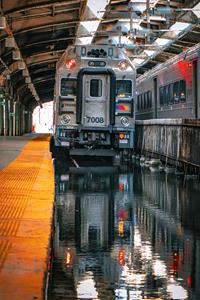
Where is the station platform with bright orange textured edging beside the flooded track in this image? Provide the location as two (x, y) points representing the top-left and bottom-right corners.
(0, 135), (54, 300)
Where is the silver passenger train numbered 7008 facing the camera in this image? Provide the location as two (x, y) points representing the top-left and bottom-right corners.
(50, 45), (136, 156)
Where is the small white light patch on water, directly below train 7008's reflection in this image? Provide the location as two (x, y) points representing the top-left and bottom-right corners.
(77, 272), (99, 300)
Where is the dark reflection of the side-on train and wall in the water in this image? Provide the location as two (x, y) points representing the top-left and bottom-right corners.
(135, 170), (200, 299)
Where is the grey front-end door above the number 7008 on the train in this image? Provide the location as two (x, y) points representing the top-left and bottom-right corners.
(81, 74), (110, 127)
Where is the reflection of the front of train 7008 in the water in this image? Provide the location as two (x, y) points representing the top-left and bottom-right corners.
(49, 173), (132, 300)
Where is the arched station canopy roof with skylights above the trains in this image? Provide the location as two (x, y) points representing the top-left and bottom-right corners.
(0, 0), (200, 109)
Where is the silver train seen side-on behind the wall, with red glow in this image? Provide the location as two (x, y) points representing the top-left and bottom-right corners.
(135, 44), (200, 120)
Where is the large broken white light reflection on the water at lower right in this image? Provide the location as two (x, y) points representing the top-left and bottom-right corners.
(115, 227), (188, 300)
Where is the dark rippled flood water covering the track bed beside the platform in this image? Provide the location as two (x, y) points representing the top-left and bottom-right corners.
(48, 164), (200, 300)
